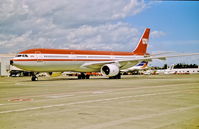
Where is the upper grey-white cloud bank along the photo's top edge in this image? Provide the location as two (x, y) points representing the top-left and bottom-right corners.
(0, 0), (146, 30)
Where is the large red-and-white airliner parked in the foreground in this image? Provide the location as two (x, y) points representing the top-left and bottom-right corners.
(10, 28), (199, 81)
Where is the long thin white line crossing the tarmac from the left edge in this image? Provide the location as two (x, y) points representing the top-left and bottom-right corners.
(0, 91), (188, 114)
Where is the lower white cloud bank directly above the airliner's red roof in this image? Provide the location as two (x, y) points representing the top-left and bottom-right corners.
(0, 22), (138, 52)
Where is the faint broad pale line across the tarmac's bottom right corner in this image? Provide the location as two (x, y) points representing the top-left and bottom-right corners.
(80, 105), (199, 129)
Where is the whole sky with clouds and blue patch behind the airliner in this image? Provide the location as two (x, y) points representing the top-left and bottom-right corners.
(0, 0), (199, 65)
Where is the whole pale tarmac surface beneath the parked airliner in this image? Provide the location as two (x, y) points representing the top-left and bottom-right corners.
(0, 74), (199, 129)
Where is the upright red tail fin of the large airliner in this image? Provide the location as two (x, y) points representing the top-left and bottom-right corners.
(132, 28), (150, 55)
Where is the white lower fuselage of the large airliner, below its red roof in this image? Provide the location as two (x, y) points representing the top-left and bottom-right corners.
(13, 54), (143, 72)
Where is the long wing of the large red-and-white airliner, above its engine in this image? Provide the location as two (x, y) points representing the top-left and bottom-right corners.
(82, 53), (199, 69)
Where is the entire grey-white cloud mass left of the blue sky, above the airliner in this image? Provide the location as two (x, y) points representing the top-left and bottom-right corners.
(0, 0), (146, 53)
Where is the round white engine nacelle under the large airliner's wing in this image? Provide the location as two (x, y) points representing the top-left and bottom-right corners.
(101, 64), (120, 77)
